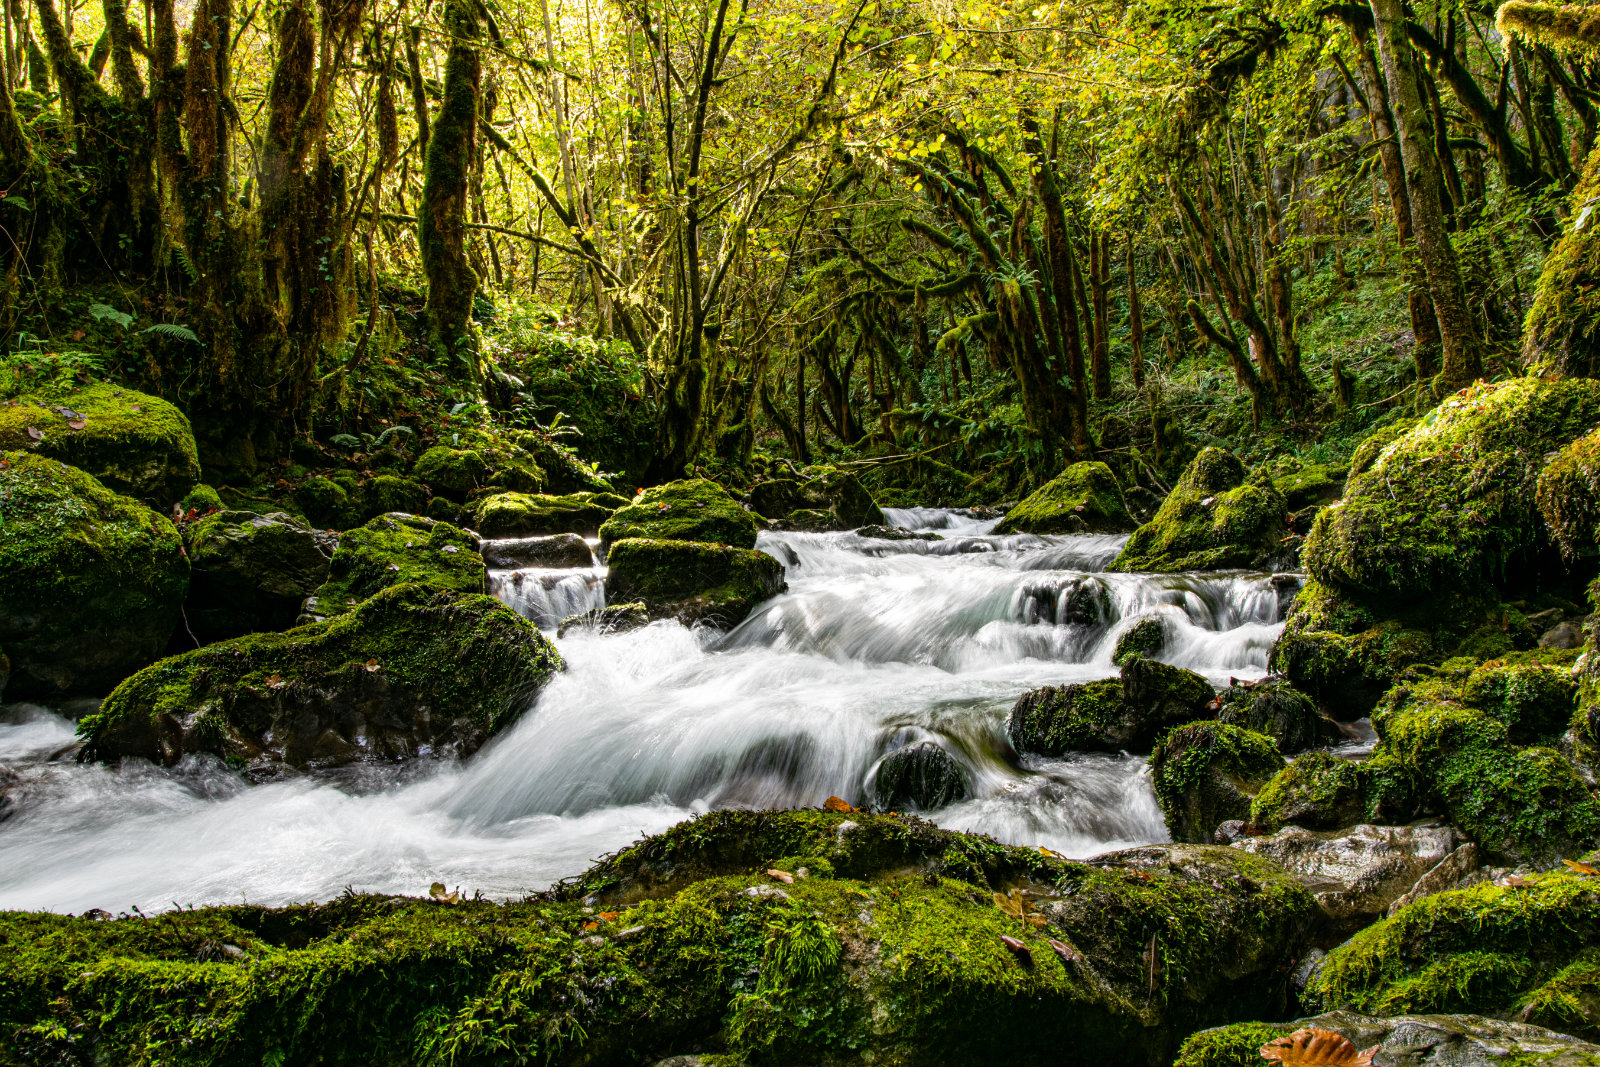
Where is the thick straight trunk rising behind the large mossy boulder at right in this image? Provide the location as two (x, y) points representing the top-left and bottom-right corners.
(1370, 0), (1483, 392)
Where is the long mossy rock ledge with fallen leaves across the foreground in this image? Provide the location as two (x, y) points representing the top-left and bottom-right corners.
(0, 811), (1315, 1067)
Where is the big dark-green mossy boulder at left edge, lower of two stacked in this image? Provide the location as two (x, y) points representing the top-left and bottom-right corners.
(0, 453), (189, 701)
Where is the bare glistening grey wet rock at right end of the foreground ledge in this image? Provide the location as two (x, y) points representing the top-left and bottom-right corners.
(1232, 824), (1462, 936)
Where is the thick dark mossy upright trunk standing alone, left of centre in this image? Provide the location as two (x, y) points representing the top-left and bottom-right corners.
(418, 0), (483, 392)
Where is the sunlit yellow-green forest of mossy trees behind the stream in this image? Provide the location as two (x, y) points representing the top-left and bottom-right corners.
(0, 0), (1600, 506)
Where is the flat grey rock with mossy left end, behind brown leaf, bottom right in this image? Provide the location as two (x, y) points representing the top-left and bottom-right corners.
(1174, 1011), (1600, 1067)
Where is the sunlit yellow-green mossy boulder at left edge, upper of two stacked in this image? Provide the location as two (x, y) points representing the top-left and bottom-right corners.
(0, 384), (200, 512)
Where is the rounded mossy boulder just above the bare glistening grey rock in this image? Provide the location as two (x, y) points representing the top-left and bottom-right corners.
(1150, 721), (1283, 841)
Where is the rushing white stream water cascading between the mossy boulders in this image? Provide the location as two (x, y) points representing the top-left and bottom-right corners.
(0, 509), (1294, 912)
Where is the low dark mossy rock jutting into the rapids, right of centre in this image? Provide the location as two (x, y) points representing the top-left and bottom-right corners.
(1006, 657), (1216, 757)
